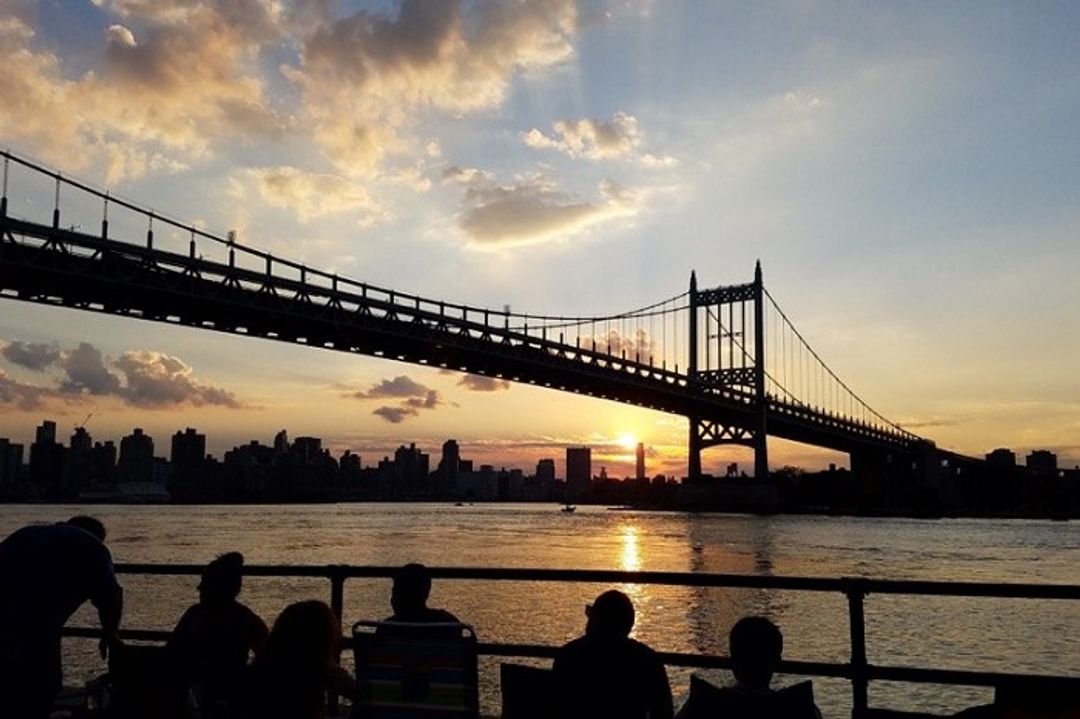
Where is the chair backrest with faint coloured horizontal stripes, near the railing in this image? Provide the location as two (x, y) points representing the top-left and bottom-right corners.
(352, 622), (480, 719)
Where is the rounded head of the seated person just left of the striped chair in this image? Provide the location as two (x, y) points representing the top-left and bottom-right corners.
(259, 599), (341, 673)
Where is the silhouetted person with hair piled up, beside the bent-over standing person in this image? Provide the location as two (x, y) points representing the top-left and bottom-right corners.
(166, 552), (269, 717)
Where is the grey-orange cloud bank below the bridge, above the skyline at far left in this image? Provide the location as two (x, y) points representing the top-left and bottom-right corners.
(0, 341), (246, 409)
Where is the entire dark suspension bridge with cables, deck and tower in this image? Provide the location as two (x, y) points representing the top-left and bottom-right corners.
(0, 152), (939, 487)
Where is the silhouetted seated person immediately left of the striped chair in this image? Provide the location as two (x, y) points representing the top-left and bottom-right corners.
(230, 599), (355, 719)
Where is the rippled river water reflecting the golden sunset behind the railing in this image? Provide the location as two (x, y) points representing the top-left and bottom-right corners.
(0, 503), (1080, 717)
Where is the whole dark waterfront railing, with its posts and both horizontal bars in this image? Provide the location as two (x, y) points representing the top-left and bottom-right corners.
(64, 564), (1080, 719)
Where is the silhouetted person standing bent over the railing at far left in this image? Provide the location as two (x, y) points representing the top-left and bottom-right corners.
(0, 516), (123, 719)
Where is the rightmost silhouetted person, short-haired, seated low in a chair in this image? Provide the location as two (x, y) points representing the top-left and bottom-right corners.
(679, 616), (821, 719)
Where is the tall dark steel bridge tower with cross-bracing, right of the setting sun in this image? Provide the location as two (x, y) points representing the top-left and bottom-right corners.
(687, 260), (769, 479)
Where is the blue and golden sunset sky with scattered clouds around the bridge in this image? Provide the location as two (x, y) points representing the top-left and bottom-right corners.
(0, 0), (1080, 476)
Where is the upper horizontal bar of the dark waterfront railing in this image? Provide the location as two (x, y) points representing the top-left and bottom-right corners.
(116, 564), (1080, 599)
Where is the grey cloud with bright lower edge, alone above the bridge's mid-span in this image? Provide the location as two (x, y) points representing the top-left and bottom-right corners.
(444, 168), (638, 247)
